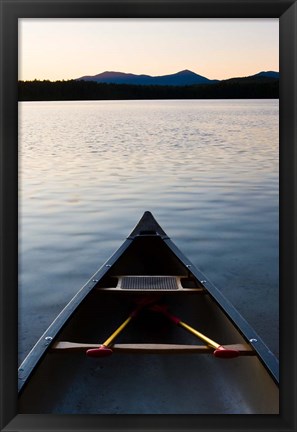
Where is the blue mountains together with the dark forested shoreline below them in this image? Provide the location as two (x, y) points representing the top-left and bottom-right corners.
(18, 70), (279, 101)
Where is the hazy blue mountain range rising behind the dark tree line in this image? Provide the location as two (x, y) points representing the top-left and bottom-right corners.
(76, 69), (279, 87)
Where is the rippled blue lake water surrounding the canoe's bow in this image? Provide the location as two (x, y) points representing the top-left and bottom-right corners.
(19, 100), (279, 361)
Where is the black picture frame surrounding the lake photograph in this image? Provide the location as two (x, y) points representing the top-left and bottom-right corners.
(0, 0), (297, 432)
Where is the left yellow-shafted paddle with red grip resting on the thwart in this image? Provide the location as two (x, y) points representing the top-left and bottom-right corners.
(86, 297), (156, 357)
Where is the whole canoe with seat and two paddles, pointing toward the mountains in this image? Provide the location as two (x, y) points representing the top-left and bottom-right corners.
(18, 212), (279, 414)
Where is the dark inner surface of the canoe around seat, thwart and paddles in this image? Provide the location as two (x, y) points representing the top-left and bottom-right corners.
(19, 236), (279, 414)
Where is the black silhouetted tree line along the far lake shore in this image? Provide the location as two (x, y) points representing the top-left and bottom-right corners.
(18, 78), (279, 101)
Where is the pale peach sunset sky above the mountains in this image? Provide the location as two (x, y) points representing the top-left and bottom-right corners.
(19, 18), (279, 81)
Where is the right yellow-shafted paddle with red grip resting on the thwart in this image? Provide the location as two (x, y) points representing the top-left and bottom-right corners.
(151, 305), (240, 358)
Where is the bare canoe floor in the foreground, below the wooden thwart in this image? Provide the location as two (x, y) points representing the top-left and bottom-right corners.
(19, 353), (278, 414)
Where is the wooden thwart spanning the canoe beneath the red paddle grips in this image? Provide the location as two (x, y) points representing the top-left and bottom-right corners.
(51, 342), (255, 356)
